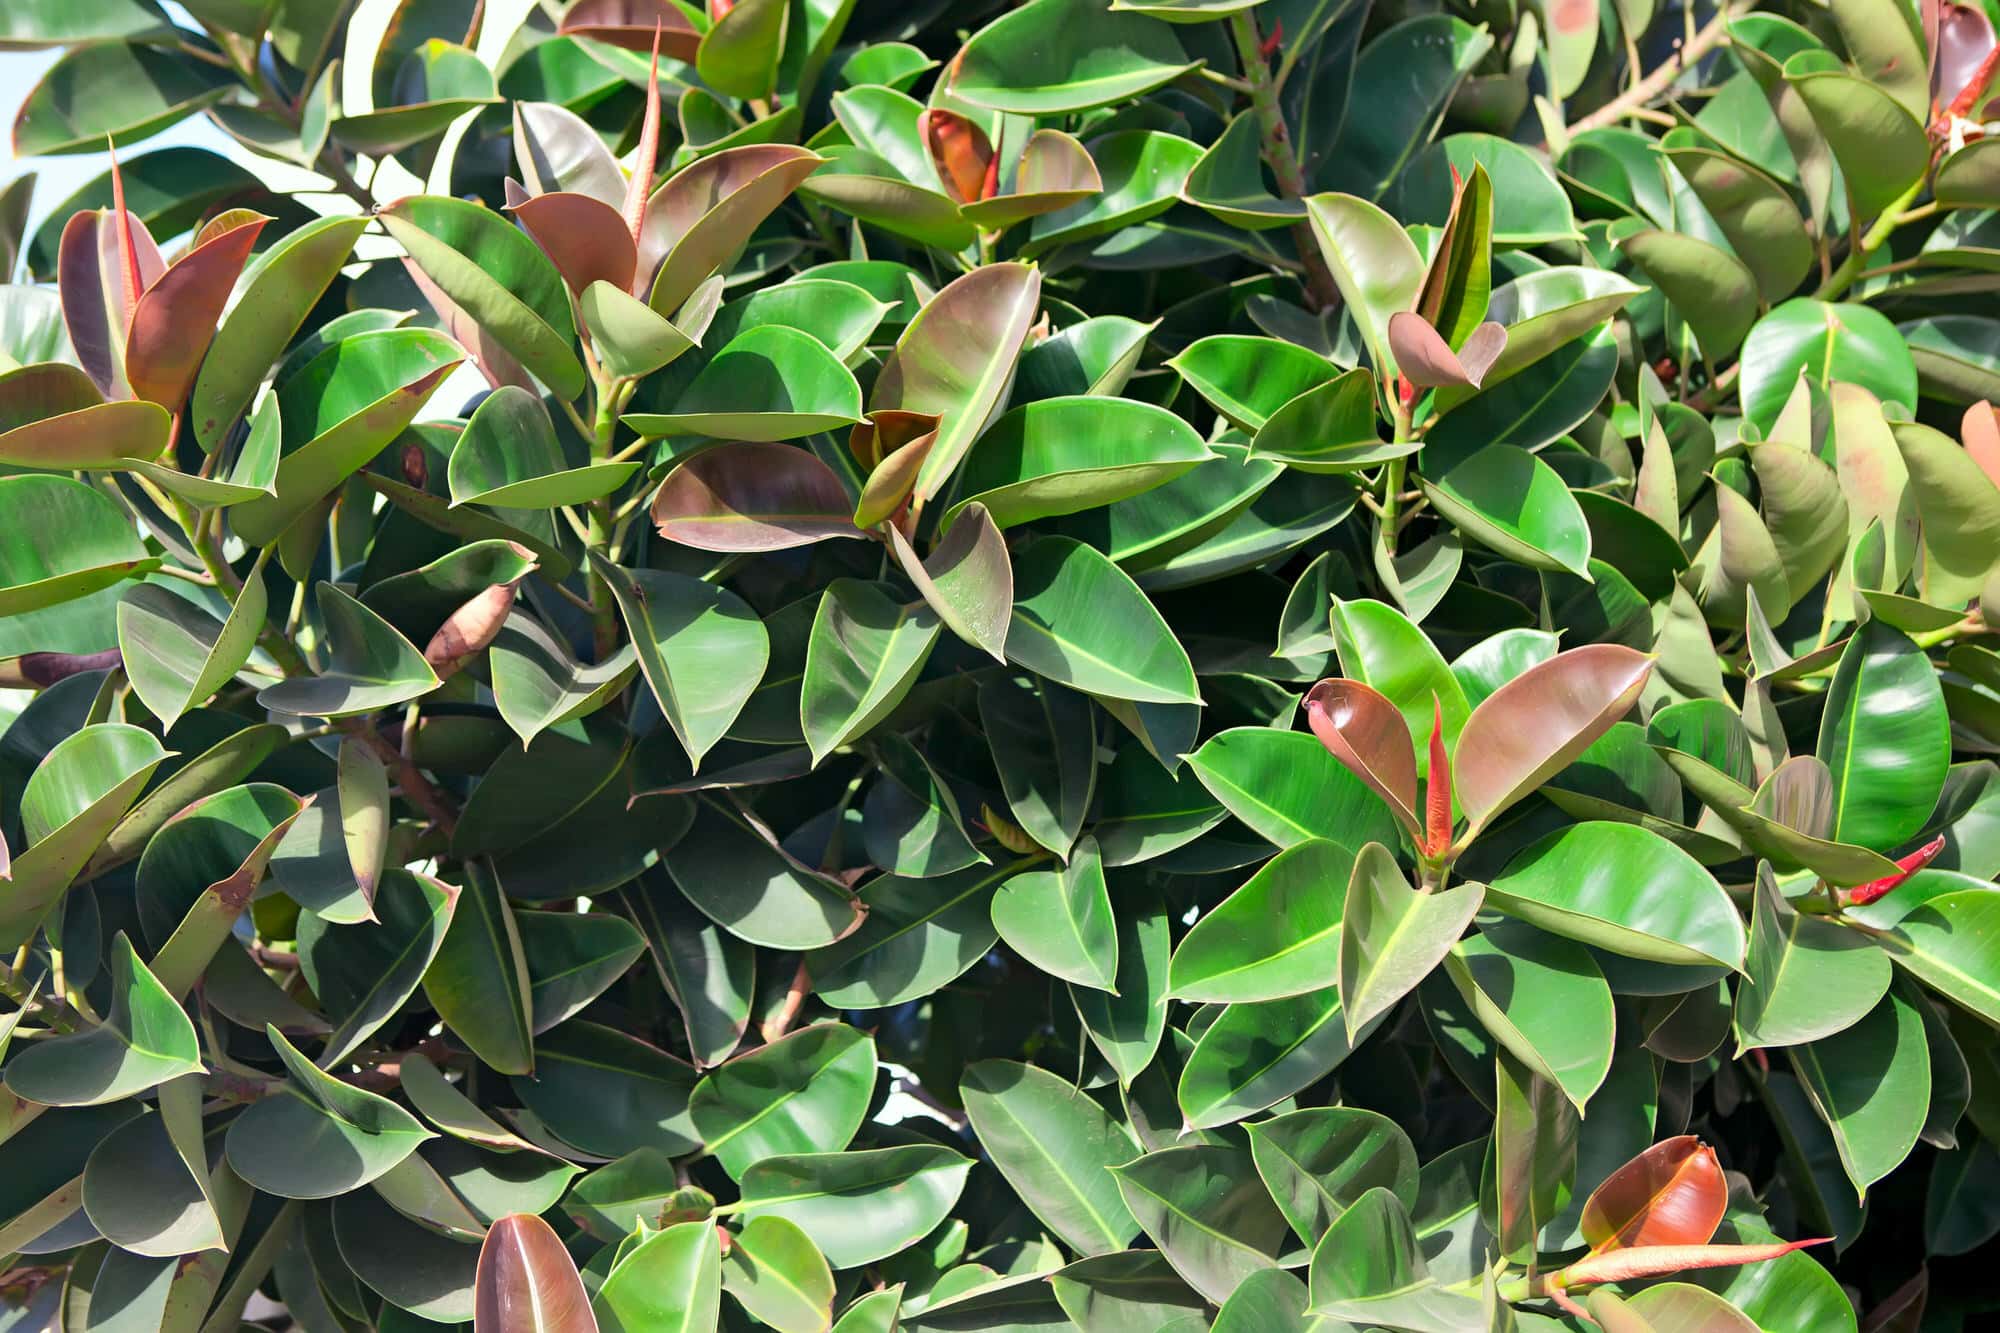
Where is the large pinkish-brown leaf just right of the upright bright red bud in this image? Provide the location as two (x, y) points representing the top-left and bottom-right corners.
(1454, 642), (1652, 831)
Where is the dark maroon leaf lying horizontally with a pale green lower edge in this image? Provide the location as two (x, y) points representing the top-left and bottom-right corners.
(652, 442), (866, 550)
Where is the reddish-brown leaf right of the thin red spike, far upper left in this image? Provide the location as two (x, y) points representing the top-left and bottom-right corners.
(126, 212), (270, 412)
